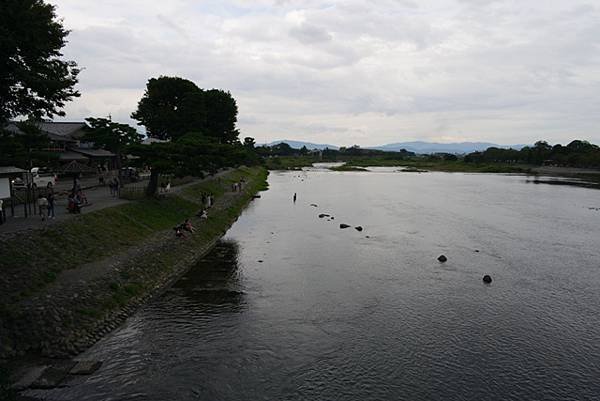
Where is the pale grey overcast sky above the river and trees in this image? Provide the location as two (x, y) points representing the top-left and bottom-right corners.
(50, 0), (600, 146)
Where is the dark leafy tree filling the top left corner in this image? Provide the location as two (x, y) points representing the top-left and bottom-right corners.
(0, 0), (79, 123)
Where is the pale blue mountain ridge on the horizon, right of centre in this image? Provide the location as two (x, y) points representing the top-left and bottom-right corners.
(370, 141), (527, 154)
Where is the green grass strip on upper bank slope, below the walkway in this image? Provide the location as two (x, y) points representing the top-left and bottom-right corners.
(0, 168), (266, 304)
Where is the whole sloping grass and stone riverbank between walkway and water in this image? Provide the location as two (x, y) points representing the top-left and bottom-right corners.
(0, 167), (267, 368)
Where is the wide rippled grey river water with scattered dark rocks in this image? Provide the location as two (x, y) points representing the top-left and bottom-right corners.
(28, 170), (600, 401)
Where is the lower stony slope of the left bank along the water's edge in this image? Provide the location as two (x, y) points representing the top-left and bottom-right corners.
(0, 168), (268, 395)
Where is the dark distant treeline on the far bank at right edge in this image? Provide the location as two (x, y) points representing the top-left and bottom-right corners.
(464, 140), (600, 168)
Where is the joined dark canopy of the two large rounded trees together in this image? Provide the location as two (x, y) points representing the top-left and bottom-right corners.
(131, 76), (239, 144)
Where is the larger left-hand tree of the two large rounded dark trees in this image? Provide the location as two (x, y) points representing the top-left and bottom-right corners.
(131, 76), (206, 140)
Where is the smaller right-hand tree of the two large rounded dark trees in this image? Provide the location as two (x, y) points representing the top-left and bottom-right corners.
(205, 89), (239, 143)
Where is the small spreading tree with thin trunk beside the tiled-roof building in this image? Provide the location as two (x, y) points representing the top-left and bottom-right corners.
(82, 118), (143, 174)
